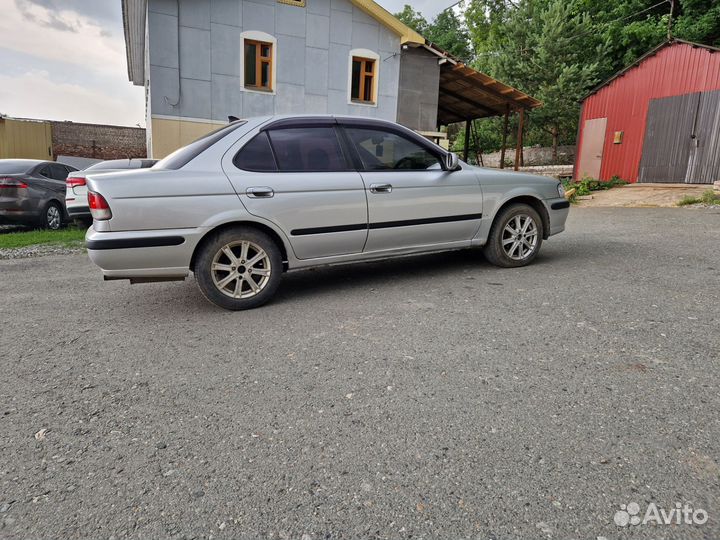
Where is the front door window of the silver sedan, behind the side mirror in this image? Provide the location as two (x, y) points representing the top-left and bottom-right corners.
(345, 127), (442, 171)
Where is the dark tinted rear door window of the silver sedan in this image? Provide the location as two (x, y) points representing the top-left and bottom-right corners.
(268, 126), (349, 172)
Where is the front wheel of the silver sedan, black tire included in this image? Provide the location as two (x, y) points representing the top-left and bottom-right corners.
(483, 203), (544, 268)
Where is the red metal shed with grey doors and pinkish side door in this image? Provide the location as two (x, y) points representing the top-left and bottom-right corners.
(574, 39), (720, 183)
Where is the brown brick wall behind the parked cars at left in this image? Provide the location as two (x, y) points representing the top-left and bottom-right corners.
(50, 122), (147, 159)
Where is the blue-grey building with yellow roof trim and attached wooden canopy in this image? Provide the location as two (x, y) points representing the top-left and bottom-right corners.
(122, 0), (539, 157)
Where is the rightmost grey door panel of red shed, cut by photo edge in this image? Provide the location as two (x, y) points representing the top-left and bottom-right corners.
(685, 90), (720, 184)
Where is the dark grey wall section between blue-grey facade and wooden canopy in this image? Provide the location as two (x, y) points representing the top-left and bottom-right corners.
(397, 48), (440, 131)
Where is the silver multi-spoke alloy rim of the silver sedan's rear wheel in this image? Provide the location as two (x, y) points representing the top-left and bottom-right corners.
(210, 240), (272, 298)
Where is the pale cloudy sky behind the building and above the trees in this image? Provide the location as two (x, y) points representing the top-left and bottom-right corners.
(0, 0), (454, 126)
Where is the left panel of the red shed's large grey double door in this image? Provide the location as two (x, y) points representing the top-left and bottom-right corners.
(638, 93), (700, 184)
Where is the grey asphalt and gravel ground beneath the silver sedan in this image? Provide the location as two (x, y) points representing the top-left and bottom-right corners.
(0, 209), (720, 540)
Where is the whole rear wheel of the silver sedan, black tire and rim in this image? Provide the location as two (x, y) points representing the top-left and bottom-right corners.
(193, 227), (283, 311)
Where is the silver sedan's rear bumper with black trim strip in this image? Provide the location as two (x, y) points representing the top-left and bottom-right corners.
(85, 227), (204, 281)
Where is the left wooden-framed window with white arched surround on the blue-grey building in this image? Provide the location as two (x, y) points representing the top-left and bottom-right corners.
(240, 30), (277, 93)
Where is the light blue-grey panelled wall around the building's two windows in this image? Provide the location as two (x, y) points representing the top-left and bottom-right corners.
(148, 0), (400, 121)
